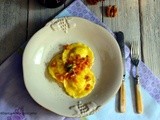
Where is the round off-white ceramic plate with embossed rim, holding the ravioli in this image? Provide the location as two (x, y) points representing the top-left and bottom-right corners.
(23, 17), (123, 117)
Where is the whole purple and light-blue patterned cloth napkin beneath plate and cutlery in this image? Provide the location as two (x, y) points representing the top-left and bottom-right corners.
(0, 0), (160, 120)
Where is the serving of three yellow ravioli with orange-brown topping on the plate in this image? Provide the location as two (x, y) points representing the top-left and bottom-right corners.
(48, 43), (96, 98)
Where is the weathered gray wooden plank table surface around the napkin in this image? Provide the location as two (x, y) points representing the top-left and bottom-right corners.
(0, 0), (160, 78)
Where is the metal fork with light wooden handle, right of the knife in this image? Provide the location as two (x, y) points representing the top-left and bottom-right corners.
(131, 41), (143, 114)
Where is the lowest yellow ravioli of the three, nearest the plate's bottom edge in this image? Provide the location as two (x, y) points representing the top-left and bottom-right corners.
(64, 68), (95, 98)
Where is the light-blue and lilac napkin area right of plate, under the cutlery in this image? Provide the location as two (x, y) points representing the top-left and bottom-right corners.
(87, 46), (160, 120)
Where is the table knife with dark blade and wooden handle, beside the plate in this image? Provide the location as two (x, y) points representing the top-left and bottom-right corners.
(115, 31), (126, 113)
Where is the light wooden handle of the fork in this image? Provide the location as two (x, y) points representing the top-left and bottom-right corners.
(135, 83), (143, 114)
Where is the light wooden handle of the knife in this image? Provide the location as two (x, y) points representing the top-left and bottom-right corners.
(120, 80), (126, 113)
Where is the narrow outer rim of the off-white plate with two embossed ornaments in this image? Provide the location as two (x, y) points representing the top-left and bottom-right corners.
(23, 17), (123, 117)
